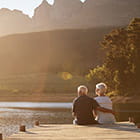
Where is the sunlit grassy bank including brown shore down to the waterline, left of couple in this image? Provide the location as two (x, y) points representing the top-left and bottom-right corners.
(0, 72), (87, 102)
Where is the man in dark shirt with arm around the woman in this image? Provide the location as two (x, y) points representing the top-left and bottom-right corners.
(72, 85), (115, 125)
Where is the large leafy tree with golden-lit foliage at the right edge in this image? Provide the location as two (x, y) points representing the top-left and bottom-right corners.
(87, 18), (140, 95)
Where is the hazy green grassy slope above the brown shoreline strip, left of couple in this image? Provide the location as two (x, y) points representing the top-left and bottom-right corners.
(0, 72), (87, 96)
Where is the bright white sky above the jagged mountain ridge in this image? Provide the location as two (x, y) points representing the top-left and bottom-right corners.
(0, 0), (85, 17)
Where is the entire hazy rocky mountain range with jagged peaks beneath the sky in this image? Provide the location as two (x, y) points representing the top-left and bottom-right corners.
(0, 0), (140, 36)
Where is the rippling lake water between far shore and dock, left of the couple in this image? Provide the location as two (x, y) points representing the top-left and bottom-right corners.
(0, 102), (72, 137)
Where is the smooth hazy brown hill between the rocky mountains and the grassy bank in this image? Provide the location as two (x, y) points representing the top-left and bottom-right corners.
(0, 27), (114, 74)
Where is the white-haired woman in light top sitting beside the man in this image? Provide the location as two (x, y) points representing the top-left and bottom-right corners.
(95, 83), (116, 124)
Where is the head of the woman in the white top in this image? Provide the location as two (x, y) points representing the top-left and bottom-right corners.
(95, 83), (107, 96)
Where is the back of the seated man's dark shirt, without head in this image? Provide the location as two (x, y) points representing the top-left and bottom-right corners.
(73, 95), (99, 124)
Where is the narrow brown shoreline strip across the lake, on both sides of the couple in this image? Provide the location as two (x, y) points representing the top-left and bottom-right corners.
(0, 93), (140, 104)
